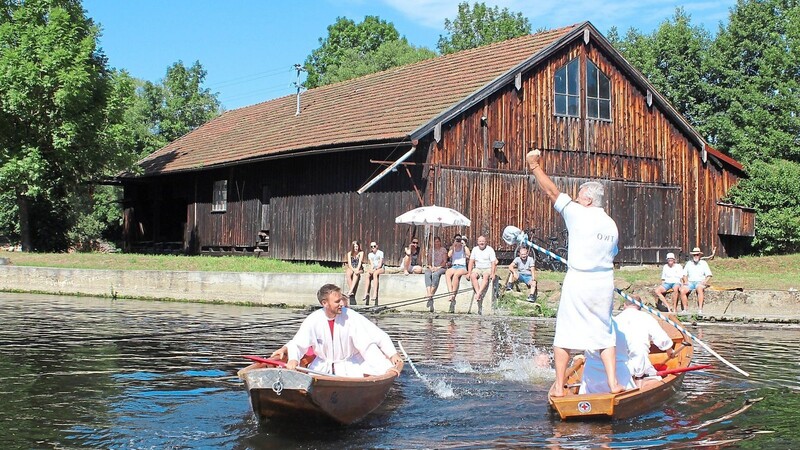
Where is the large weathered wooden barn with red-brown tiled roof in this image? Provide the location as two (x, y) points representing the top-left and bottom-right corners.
(117, 22), (754, 265)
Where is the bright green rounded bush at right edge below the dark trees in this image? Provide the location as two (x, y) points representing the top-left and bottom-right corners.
(729, 160), (800, 254)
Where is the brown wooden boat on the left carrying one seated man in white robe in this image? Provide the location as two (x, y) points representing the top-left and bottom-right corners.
(238, 363), (397, 425)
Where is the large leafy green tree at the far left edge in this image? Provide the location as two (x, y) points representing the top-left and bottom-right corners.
(0, 0), (115, 251)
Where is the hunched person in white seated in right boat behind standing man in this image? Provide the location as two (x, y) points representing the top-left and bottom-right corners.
(614, 295), (673, 387)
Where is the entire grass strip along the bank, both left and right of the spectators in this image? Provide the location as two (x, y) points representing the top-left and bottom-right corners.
(0, 251), (800, 290)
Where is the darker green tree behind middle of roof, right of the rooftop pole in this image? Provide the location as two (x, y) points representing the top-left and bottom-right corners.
(304, 16), (400, 89)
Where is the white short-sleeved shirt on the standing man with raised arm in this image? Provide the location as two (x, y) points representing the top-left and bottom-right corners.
(553, 193), (619, 272)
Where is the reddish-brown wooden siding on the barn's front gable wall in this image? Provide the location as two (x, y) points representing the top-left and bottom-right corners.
(428, 42), (752, 262)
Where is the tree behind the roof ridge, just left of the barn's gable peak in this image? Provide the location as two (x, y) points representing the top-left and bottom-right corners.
(438, 2), (531, 55)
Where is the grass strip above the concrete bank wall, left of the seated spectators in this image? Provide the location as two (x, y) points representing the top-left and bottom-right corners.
(0, 251), (341, 273)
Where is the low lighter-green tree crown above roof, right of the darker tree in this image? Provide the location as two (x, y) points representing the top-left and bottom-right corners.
(324, 38), (436, 84)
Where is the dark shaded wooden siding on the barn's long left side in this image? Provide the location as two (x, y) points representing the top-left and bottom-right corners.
(125, 145), (425, 264)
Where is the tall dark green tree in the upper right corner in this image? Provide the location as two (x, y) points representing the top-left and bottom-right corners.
(706, 0), (800, 162)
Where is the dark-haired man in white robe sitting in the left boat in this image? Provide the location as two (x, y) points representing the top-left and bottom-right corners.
(272, 284), (403, 377)
